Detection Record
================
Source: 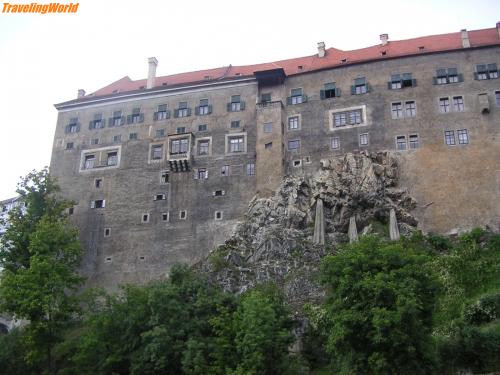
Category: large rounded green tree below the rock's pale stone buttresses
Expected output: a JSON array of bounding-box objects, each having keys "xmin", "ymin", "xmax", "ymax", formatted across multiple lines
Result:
[{"xmin": 322, "ymin": 236, "xmax": 437, "ymax": 374}]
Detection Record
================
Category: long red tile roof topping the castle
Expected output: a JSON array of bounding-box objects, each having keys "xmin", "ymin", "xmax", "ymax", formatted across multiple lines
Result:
[{"xmin": 88, "ymin": 28, "xmax": 500, "ymax": 99}]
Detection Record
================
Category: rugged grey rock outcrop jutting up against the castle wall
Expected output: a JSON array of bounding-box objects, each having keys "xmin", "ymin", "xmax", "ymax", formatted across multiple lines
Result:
[{"xmin": 197, "ymin": 152, "xmax": 417, "ymax": 306}]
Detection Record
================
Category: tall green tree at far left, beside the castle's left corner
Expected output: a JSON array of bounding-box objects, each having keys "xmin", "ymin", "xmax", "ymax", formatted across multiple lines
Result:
[{"xmin": 0, "ymin": 169, "xmax": 83, "ymax": 373}]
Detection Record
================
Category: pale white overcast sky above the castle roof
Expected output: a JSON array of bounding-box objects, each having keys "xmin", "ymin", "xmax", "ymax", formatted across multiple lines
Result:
[{"xmin": 0, "ymin": 0, "xmax": 500, "ymax": 200}]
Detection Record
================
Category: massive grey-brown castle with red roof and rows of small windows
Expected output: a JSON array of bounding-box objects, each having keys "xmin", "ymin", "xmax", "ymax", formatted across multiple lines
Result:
[{"xmin": 50, "ymin": 23, "xmax": 500, "ymax": 287}]
